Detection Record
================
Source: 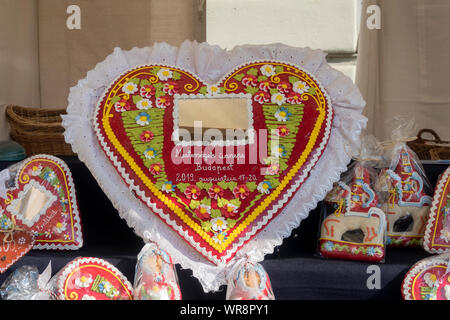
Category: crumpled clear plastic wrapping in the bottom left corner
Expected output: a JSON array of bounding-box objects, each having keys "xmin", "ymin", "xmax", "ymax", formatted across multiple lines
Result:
[{"xmin": 0, "ymin": 264, "xmax": 56, "ymax": 300}]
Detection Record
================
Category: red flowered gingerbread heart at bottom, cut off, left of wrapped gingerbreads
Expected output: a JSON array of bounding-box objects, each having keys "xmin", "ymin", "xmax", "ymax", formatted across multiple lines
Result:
[{"xmin": 57, "ymin": 257, "xmax": 133, "ymax": 300}]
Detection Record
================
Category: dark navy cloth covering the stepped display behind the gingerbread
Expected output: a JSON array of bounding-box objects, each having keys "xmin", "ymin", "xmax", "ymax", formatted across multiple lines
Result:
[{"xmin": 0, "ymin": 157, "xmax": 447, "ymax": 300}]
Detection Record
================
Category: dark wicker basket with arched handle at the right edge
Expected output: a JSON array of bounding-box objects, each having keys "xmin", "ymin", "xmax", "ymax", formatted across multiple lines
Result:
[{"xmin": 408, "ymin": 129, "xmax": 450, "ymax": 160}]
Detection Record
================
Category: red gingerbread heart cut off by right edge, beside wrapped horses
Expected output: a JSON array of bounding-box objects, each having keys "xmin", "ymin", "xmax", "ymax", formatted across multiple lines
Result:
[{"xmin": 423, "ymin": 167, "xmax": 450, "ymax": 253}]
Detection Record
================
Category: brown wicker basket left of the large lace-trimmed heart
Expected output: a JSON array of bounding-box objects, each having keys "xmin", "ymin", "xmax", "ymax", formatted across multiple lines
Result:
[{"xmin": 6, "ymin": 105, "xmax": 74, "ymax": 156}]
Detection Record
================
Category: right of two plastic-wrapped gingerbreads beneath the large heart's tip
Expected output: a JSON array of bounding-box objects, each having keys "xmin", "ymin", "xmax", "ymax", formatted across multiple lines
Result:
[{"xmin": 226, "ymin": 260, "xmax": 275, "ymax": 300}]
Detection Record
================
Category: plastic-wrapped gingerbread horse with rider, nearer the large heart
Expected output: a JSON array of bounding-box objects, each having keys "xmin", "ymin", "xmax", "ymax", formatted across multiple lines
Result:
[{"xmin": 318, "ymin": 136, "xmax": 386, "ymax": 262}]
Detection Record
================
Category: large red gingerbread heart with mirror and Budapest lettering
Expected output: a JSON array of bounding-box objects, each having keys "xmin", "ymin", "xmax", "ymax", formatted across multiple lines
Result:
[{"xmin": 94, "ymin": 61, "xmax": 333, "ymax": 264}]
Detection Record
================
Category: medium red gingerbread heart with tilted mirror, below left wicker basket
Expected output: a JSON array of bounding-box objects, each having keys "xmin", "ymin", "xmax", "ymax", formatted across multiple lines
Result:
[{"xmin": 0, "ymin": 155, "xmax": 83, "ymax": 249}]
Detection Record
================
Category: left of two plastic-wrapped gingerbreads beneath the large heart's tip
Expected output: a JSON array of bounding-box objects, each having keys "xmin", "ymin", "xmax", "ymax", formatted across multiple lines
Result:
[{"xmin": 134, "ymin": 242, "xmax": 181, "ymax": 300}]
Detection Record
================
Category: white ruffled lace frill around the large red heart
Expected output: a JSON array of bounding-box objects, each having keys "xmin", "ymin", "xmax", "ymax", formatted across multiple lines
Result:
[{"xmin": 63, "ymin": 41, "xmax": 367, "ymax": 292}]
